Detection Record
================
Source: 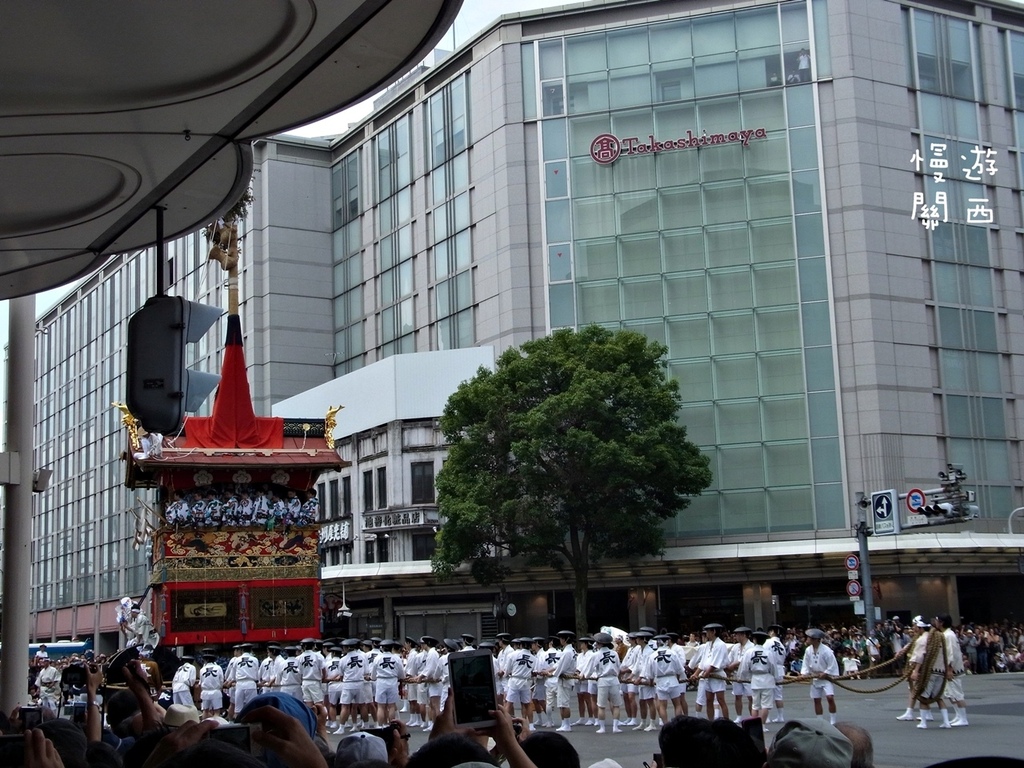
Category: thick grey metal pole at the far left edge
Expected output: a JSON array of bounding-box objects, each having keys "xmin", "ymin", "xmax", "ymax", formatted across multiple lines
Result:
[{"xmin": 0, "ymin": 296, "xmax": 36, "ymax": 712}]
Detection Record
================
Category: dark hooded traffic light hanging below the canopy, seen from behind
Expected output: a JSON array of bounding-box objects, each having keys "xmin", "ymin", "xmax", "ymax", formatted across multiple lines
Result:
[{"xmin": 125, "ymin": 296, "xmax": 224, "ymax": 434}]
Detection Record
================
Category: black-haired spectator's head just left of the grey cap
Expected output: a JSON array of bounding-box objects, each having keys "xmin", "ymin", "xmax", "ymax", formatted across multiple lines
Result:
[{"xmin": 657, "ymin": 715, "xmax": 764, "ymax": 768}]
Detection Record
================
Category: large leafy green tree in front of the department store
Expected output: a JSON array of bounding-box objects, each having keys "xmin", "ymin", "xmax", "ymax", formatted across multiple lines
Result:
[{"xmin": 433, "ymin": 326, "xmax": 712, "ymax": 633}]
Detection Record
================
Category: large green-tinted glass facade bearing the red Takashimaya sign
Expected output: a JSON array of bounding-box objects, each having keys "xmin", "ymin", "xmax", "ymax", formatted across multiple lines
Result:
[{"xmin": 522, "ymin": 2, "xmax": 844, "ymax": 536}]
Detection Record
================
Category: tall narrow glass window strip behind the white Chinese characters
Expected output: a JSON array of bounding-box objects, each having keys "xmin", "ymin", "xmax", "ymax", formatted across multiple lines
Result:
[{"xmin": 903, "ymin": 8, "xmax": 1024, "ymax": 518}]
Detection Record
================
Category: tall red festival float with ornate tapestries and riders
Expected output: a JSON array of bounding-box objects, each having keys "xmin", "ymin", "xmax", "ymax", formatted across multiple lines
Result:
[{"xmin": 115, "ymin": 221, "xmax": 348, "ymax": 647}]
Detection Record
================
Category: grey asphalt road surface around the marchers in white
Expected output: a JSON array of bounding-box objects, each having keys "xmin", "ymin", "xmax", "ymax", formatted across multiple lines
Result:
[{"xmin": 331, "ymin": 673, "xmax": 1024, "ymax": 768}]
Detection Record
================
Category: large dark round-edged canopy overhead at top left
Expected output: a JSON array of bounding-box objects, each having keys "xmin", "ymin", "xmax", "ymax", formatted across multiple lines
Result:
[{"xmin": 0, "ymin": 0, "xmax": 462, "ymax": 298}]
